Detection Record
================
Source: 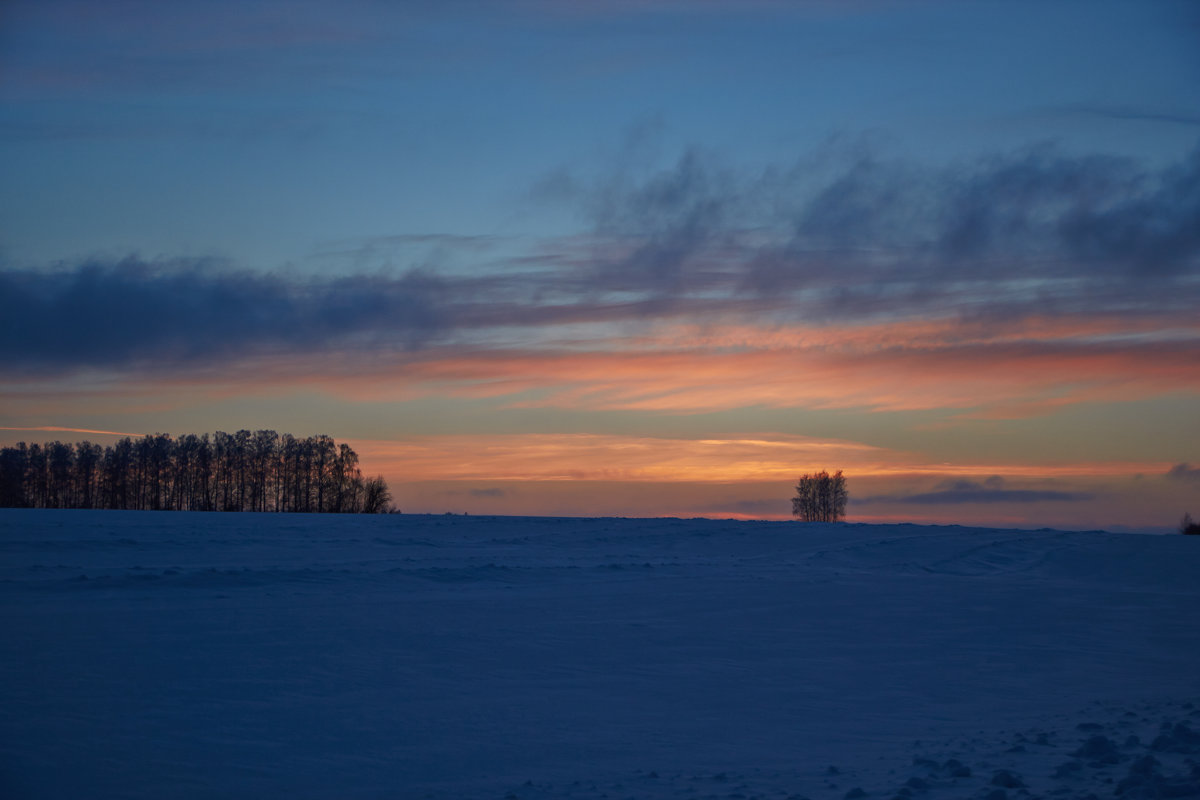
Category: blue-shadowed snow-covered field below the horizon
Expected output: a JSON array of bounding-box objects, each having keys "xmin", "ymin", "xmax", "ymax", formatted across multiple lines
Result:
[{"xmin": 0, "ymin": 510, "xmax": 1200, "ymax": 800}]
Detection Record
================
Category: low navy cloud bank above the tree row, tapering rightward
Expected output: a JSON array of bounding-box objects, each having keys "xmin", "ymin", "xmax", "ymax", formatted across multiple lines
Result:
[{"xmin": 0, "ymin": 254, "xmax": 777, "ymax": 373}]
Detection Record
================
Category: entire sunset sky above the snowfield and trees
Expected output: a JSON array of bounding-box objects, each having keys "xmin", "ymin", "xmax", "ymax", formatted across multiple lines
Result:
[{"xmin": 0, "ymin": 0, "xmax": 1200, "ymax": 530}]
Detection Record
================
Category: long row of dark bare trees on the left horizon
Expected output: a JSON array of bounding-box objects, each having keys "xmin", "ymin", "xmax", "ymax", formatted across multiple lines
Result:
[{"xmin": 0, "ymin": 431, "xmax": 391, "ymax": 513}]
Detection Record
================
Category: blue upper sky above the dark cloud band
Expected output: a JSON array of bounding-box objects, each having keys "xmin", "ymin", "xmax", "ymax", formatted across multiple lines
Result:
[{"xmin": 2, "ymin": 0, "xmax": 1200, "ymax": 269}]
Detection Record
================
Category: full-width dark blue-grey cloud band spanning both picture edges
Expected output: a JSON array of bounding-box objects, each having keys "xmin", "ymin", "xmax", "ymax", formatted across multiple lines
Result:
[{"xmin": 0, "ymin": 141, "xmax": 1200, "ymax": 372}]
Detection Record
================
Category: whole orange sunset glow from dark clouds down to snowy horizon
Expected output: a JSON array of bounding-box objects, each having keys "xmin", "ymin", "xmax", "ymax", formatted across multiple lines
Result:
[{"xmin": 2, "ymin": 319, "xmax": 1200, "ymax": 527}]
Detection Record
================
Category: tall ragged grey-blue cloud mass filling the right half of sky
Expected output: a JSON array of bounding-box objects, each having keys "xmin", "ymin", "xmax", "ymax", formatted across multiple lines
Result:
[{"xmin": 553, "ymin": 137, "xmax": 1200, "ymax": 319}]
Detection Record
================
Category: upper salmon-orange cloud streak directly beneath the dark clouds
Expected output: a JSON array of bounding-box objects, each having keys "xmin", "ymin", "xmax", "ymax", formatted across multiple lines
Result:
[{"xmin": 226, "ymin": 328, "xmax": 1200, "ymax": 417}]
